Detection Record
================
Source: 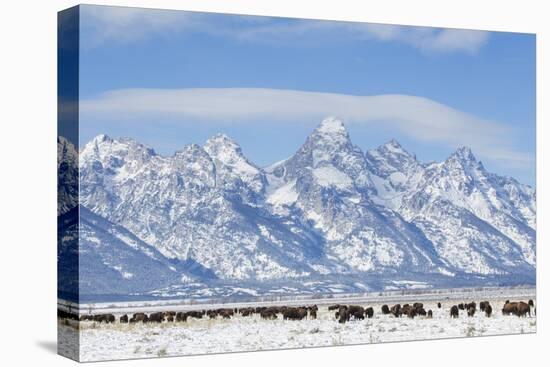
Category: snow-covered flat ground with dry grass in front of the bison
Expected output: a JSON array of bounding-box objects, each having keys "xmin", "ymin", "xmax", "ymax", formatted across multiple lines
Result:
[{"xmin": 59, "ymin": 295, "xmax": 536, "ymax": 361}]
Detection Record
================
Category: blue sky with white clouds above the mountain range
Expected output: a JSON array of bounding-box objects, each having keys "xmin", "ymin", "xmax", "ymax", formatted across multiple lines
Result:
[{"xmin": 80, "ymin": 6, "xmax": 535, "ymax": 185}]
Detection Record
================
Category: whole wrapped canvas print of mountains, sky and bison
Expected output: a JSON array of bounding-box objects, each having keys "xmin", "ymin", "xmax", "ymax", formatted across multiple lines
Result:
[{"xmin": 57, "ymin": 5, "xmax": 537, "ymax": 361}]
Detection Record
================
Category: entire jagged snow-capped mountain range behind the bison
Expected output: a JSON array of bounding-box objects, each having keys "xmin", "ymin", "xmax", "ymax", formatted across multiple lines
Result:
[{"xmin": 58, "ymin": 118, "xmax": 536, "ymax": 302}]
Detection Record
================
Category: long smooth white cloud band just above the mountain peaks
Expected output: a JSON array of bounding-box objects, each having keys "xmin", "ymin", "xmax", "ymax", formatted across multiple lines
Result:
[{"xmin": 80, "ymin": 88, "xmax": 533, "ymax": 166}]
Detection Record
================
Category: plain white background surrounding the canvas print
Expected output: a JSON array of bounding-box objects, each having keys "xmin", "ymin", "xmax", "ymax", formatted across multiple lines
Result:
[{"xmin": 0, "ymin": 0, "xmax": 550, "ymax": 367}]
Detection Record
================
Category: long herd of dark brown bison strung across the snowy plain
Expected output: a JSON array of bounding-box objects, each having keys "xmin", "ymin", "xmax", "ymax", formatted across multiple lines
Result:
[{"xmin": 57, "ymin": 300, "xmax": 536, "ymax": 324}]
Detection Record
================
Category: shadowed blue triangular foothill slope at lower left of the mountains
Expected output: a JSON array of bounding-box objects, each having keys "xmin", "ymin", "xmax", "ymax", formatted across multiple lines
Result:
[{"xmin": 58, "ymin": 207, "xmax": 194, "ymax": 295}]
